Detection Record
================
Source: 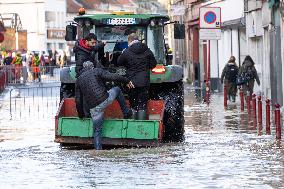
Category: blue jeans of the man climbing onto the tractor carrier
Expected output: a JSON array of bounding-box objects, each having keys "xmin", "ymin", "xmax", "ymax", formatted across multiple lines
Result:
[{"xmin": 90, "ymin": 87, "xmax": 129, "ymax": 150}]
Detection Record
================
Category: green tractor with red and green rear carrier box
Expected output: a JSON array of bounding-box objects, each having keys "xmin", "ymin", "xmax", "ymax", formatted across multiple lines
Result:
[{"xmin": 55, "ymin": 12, "xmax": 184, "ymax": 145}]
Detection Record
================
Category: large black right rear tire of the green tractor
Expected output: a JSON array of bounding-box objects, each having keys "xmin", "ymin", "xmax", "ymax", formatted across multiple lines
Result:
[{"xmin": 150, "ymin": 81, "xmax": 184, "ymax": 142}]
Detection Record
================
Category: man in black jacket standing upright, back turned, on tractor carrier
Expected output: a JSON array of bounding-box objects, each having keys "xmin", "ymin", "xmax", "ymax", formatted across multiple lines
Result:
[{"xmin": 117, "ymin": 33, "xmax": 157, "ymax": 119}]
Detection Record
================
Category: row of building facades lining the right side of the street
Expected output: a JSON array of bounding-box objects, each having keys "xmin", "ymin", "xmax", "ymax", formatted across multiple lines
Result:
[{"xmin": 169, "ymin": 0, "xmax": 284, "ymax": 105}]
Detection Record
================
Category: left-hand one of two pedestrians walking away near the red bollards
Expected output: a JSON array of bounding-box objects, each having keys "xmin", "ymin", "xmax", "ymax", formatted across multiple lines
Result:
[{"xmin": 221, "ymin": 56, "xmax": 239, "ymax": 102}]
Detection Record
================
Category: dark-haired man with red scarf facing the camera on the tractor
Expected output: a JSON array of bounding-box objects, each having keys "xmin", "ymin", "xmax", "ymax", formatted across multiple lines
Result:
[{"xmin": 73, "ymin": 33, "xmax": 105, "ymax": 77}]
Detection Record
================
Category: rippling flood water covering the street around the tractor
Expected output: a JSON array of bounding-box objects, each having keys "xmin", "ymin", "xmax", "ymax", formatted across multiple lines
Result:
[{"xmin": 0, "ymin": 87, "xmax": 284, "ymax": 189}]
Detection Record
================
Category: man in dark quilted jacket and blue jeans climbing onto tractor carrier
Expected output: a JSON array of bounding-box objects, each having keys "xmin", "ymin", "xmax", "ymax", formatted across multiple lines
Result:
[{"xmin": 75, "ymin": 61, "xmax": 134, "ymax": 150}]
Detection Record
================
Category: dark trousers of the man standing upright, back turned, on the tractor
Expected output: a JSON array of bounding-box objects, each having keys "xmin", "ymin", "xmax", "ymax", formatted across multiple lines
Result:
[{"xmin": 128, "ymin": 87, "xmax": 149, "ymax": 111}]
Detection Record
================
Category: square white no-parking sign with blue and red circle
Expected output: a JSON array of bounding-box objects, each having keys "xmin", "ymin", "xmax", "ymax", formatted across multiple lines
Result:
[{"xmin": 199, "ymin": 7, "xmax": 221, "ymax": 29}]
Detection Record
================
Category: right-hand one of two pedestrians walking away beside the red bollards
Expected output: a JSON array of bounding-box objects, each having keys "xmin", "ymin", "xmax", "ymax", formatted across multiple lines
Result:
[{"xmin": 238, "ymin": 55, "xmax": 260, "ymax": 95}]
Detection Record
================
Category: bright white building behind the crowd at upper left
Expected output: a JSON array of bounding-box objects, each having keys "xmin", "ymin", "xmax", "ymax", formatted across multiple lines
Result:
[{"xmin": 0, "ymin": 0, "xmax": 66, "ymax": 51}]
